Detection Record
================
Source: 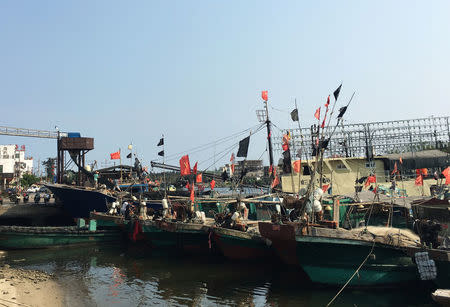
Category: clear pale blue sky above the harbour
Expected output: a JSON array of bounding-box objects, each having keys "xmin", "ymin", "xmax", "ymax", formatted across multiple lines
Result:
[{"xmin": 0, "ymin": 0, "xmax": 450, "ymax": 173}]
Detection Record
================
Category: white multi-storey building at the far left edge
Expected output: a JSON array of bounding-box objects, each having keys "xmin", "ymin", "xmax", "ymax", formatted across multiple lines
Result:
[{"xmin": 0, "ymin": 145, "xmax": 33, "ymax": 187}]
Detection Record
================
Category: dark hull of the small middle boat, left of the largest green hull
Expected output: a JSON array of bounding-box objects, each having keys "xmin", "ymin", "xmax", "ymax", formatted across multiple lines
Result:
[{"xmin": 213, "ymin": 227, "xmax": 275, "ymax": 260}]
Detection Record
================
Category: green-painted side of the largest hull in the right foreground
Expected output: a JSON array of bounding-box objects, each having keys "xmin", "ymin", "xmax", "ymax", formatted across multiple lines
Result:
[{"xmin": 296, "ymin": 236, "xmax": 419, "ymax": 286}]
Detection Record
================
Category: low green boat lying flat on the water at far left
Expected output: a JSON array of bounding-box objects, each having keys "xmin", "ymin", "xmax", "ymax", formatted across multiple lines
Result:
[{"xmin": 0, "ymin": 226, "xmax": 122, "ymax": 249}]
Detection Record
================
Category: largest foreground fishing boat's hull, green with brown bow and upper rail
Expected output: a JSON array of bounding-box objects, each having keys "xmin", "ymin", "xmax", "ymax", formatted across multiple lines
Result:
[{"xmin": 259, "ymin": 223, "xmax": 432, "ymax": 287}]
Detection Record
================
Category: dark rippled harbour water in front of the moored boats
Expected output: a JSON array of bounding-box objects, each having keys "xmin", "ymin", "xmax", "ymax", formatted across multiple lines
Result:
[{"xmin": 3, "ymin": 246, "xmax": 434, "ymax": 307}]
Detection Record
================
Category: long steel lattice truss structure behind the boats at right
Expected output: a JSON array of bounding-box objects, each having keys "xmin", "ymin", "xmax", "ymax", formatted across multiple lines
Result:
[{"xmin": 274, "ymin": 116, "xmax": 450, "ymax": 159}]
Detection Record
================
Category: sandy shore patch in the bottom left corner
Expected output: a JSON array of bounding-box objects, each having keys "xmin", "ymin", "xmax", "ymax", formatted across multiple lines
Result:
[{"xmin": 0, "ymin": 264, "xmax": 64, "ymax": 307}]
